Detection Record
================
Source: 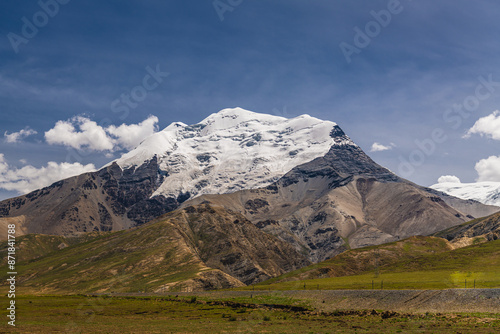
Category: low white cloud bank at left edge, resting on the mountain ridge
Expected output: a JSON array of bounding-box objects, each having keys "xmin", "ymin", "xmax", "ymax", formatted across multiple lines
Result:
[{"xmin": 0, "ymin": 153, "xmax": 96, "ymax": 194}]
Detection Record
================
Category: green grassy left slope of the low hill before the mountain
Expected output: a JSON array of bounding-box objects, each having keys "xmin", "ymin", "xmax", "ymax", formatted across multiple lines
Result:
[{"xmin": 7, "ymin": 219, "xmax": 208, "ymax": 292}]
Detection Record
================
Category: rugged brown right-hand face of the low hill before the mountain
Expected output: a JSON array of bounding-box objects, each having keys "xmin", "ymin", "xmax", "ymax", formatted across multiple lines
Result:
[{"xmin": 178, "ymin": 204, "xmax": 310, "ymax": 284}]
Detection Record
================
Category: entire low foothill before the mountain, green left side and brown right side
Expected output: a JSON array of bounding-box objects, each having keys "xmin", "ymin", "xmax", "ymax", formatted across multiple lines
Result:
[{"xmin": 8, "ymin": 201, "xmax": 310, "ymax": 293}]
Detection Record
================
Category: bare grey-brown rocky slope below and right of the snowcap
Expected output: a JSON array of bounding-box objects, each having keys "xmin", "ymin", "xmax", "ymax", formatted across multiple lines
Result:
[{"xmin": 190, "ymin": 138, "xmax": 480, "ymax": 262}]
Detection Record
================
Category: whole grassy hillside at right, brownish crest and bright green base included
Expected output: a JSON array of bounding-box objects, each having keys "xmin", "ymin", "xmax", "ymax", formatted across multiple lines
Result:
[{"xmin": 246, "ymin": 237, "xmax": 500, "ymax": 290}]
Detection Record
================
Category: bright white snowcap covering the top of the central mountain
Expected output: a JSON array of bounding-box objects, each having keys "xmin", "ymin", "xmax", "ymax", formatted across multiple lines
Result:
[{"xmin": 116, "ymin": 108, "xmax": 355, "ymax": 201}]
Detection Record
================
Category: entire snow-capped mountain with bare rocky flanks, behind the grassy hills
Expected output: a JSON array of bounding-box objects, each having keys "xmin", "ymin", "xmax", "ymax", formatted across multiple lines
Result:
[{"xmin": 0, "ymin": 108, "xmax": 499, "ymax": 261}]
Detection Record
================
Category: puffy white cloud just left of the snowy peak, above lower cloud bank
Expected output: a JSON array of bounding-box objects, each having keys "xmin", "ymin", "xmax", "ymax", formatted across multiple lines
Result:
[{"xmin": 45, "ymin": 116, "xmax": 158, "ymax": 152}]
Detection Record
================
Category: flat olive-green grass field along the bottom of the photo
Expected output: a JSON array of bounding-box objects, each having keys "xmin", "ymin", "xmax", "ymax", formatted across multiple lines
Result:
[{"xmin": 0, "ymin": 296, "xmax": 500, "ymax": 333}]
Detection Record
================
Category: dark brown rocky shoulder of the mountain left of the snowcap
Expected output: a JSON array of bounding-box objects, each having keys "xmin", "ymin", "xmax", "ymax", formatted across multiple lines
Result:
[{"xmin": 0, "ymin": 159, "xmax": 173, "ymax": 238}]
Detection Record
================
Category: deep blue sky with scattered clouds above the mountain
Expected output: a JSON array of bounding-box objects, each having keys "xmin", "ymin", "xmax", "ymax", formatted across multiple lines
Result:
[{"xmin": 0, "ymin": 0, "xmax": 500, "ymax": 199}]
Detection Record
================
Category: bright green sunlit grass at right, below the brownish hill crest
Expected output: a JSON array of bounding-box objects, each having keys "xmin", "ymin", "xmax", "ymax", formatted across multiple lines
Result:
[{"xmin": 240, "ymin": 240, "xmax": 500, "ymax": 290}]
